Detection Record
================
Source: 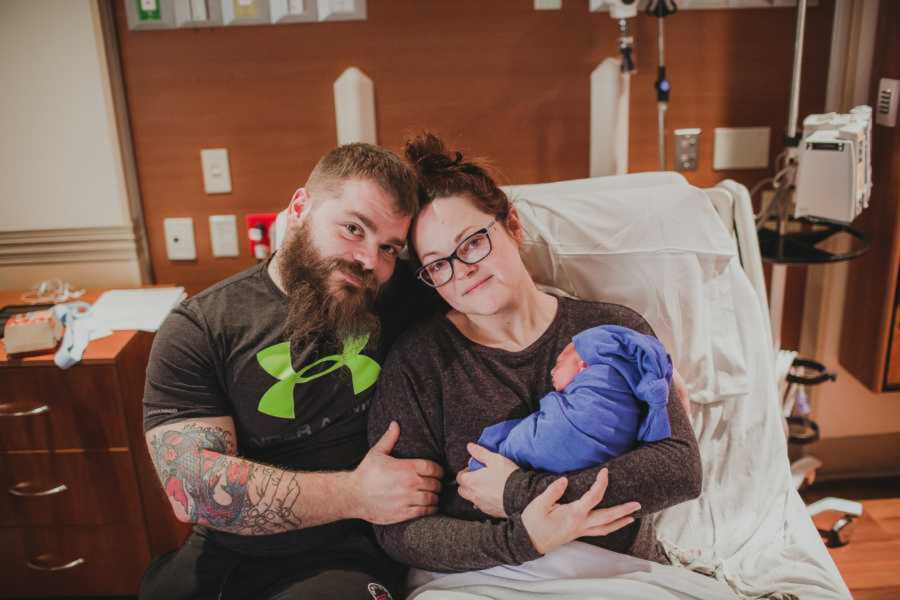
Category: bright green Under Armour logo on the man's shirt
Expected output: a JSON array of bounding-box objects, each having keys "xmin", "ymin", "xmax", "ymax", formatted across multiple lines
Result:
[{"xmin": 256, "ymin": 335, "xmax": 381, "ymax": 419}]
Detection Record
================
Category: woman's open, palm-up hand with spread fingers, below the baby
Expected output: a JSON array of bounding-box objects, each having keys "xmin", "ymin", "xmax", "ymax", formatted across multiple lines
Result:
[{"xmin": 522, "ymin": 469, "xmax": 641, "ymax": 554}]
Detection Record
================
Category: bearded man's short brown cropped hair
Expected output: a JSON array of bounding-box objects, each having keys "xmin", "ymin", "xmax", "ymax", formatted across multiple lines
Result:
[{"xmin": 306, "ymin": 142, "xmax": 419, "ymax": 216}]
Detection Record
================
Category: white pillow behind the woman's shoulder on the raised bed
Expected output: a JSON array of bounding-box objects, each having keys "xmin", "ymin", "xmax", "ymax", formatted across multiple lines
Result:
[{"xmin": 504, "ymin": 173, "xmax": 749, "ymax": 403}]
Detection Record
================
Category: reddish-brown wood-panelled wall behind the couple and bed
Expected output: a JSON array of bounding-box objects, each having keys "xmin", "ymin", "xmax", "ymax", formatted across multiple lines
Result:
[{"xmin": 116, "ymin": 0, "xmax": 833, "ymax": 346}]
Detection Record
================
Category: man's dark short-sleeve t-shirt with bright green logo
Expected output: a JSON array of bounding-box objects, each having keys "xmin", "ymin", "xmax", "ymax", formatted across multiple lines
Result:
[{"xmin": 144, "ymin": 255, "xmax": 389, "ymax": 555}]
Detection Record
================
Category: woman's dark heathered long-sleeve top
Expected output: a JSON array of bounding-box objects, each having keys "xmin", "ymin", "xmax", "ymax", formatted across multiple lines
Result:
[{"xmin": 369, "ymin": 298, "xmax": 702, "ymax": 572}]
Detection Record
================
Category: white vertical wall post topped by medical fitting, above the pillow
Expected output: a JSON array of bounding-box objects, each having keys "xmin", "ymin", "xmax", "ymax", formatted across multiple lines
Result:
[{"xmin": 588, "ymin": 0, "xmax": 638, "ymax": 177}]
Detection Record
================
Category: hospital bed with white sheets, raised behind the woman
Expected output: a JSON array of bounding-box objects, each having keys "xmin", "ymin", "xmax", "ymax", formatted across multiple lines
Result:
[{"xmin": 274, "ymin": 172, "xmax": 850, "ymax": 600}]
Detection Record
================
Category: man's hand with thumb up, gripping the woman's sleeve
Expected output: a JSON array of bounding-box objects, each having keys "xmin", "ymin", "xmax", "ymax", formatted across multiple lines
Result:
[{"xmin": 350, "ymin": 421, "xmax": 444, "ymax": 525}]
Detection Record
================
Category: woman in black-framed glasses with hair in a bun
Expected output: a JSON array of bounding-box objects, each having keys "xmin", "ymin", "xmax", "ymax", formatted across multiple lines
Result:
[{"xmin": 369, "ymin": 134, "xmax": 701, "ymax": 572}]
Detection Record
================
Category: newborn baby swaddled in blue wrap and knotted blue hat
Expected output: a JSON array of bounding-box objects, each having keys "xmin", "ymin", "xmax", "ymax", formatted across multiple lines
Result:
[{"xmin": 469, "ymin": 325, "xmax": 672, "ymax": 473}]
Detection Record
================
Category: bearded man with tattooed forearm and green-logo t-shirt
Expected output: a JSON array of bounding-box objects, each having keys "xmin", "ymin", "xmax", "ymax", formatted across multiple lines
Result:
[{"xmin": 140, "ymin": 144, "xmax": 442, "ymax": 600}]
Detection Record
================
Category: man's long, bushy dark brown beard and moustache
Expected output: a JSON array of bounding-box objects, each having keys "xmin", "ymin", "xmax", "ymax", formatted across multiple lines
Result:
[{"xmin": 276, "ymin": 222, "xmax": 380, "ymax": 353}]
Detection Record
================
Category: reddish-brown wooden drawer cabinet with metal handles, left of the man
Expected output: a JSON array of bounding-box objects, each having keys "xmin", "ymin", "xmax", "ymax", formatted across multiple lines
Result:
[{"xmin": 0, "ymin": 293, "xmax": 188, "ymax": 598}]
